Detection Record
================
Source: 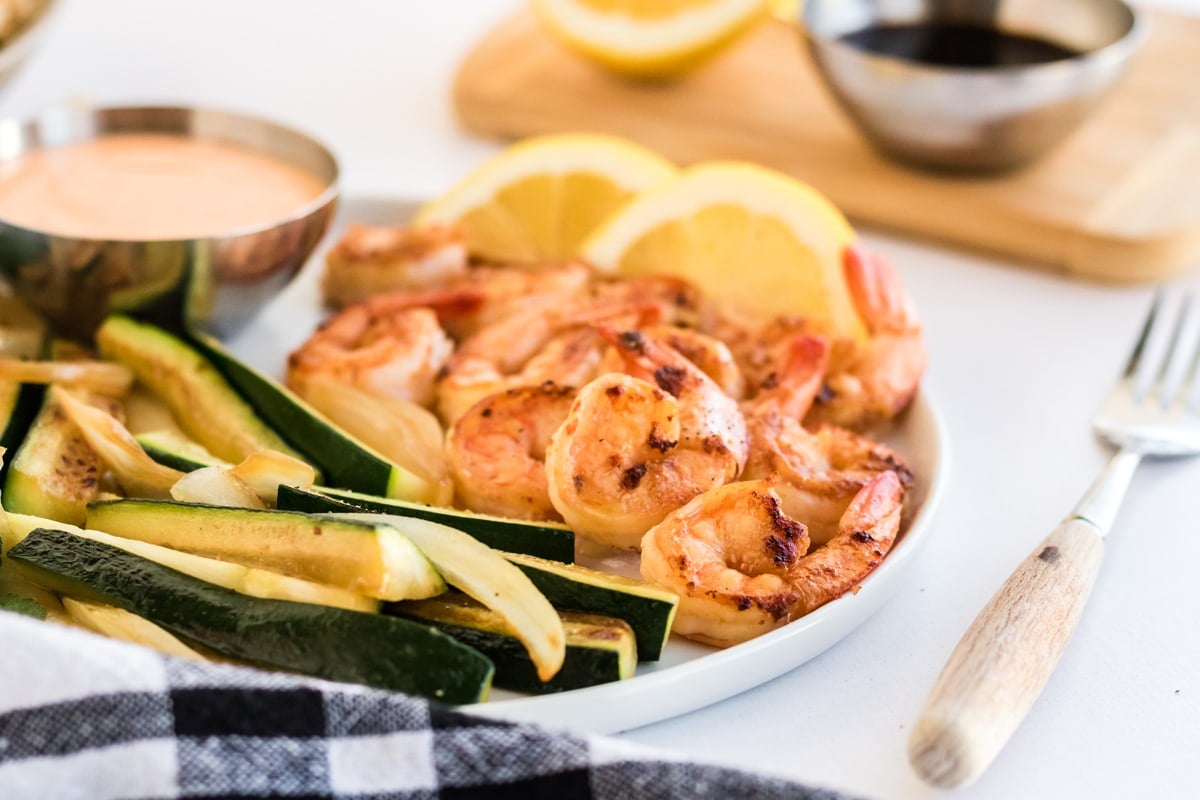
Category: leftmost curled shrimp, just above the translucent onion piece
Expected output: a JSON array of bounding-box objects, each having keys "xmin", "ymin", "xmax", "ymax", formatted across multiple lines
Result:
[{"xmin": 287, "ymin": 303, "xmax": 454, "ymax": 405}]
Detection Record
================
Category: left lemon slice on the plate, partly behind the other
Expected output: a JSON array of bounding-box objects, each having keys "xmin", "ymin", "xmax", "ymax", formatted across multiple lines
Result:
[{"xmin": 415, "ymin": 133, "xmax": 676, "ymax": 263}]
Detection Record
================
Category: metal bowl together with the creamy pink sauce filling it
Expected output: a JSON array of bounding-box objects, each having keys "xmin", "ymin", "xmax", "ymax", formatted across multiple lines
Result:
[{"xmin": 0, "ymin": 107, "xmax": 338, "ymax": 339}]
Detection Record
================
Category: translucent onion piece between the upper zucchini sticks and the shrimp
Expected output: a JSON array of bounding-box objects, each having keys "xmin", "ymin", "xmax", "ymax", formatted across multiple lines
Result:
[{"xmin": 300, "ymin": 377, "xmax": 454, "ymax": 505}]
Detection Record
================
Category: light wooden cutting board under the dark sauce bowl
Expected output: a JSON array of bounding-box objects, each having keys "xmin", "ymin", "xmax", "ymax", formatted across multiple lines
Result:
[{"xmin": 454, "ymin": 12, "xmax": 1200, "ymax": 282}]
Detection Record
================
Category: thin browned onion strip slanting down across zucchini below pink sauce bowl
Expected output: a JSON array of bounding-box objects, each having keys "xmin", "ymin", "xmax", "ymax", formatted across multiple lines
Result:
[{"xmin": 50, "ymin": 386, "xmax": 184, "ymax": 499}]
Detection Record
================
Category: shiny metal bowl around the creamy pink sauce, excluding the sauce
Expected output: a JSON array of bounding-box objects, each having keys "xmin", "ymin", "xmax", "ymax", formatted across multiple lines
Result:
[{"xmin": 0, "ymin": 107, "xmax": 338, "ymax": 338}]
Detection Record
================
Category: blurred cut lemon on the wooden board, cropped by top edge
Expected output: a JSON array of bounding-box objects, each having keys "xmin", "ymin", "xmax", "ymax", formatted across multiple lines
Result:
[{"xmin": 533, "ymin": 0, "xmax": 769, "ymax": 77}]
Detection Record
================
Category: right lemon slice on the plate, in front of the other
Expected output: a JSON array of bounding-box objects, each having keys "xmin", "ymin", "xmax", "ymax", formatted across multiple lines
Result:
[{"xmin": 583, "ymin": 163, "xmax": 865, "ymax": 338}]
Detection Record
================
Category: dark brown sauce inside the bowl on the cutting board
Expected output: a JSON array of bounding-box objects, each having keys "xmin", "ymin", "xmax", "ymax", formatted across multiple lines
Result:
[{"xmin": 841, "ymin": 23, "xmax": 1080, "ymax": 67}]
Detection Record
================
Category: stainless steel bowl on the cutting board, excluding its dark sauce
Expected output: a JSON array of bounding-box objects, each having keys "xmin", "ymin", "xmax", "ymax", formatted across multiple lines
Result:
[{"xmin": 800, "ymin": 0, "xmax": 1145, "ymax": 170}]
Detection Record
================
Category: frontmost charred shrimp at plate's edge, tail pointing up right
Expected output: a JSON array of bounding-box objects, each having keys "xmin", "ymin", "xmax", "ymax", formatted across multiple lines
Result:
[{"xmin": 641, "ymin": 473, "xmax": 904, "ymax": 646}]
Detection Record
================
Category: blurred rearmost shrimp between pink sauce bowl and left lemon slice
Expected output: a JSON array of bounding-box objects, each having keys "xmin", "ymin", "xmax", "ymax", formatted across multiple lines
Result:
[{"xmin": 322, "ymin": 223, "xmax": 467, "ymax": 308}]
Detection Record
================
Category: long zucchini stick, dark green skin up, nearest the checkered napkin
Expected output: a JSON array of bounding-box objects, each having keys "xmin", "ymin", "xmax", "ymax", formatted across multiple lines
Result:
[{"xmin": 8, "ymin": 528, "xmax": 493, "ymax": 704}]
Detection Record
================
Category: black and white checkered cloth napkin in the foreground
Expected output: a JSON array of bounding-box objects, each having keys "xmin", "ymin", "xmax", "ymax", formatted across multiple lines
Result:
[{"xmin": 0, "ymin": 612, "xmax": 840, "ymax": 800}]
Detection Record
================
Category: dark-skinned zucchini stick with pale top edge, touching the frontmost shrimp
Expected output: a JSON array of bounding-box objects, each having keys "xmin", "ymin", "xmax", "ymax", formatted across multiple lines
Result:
[{"xmin": 506, "ymin": 553, "xmax": 679, "ymax": 661}]
